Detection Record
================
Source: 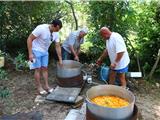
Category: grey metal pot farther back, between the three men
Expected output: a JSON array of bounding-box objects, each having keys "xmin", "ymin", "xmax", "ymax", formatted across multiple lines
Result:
[{"xmin": 57, "ymin": 60, "xmax": 82, "ymax": 78}]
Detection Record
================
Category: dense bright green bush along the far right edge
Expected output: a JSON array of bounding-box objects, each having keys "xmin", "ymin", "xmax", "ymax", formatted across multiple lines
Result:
[{"xmin": 137, "ymin": 1, "xmax": 160, "ymax": 71}]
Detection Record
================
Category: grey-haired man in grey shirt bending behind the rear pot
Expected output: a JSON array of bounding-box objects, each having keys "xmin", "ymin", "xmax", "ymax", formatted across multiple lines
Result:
[{"xmin": 62, "ymin": 28, "xmax": 88, "ymax": 61}]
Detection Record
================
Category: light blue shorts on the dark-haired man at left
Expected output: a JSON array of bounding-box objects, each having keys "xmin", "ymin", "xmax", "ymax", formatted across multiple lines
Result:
[{"xmin": 32, "ymin": 50, "xmax": 48, "ymax": 69}]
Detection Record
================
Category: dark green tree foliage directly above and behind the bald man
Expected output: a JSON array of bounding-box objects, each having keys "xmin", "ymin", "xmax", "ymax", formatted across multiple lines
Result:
[{"xmin": 86, "ymin": 1, "xmax": 135, "ymax": 62}]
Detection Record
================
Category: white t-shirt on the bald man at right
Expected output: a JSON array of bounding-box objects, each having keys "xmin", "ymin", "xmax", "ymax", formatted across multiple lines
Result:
[{"xmin": 106, "ymin": 32, "xmax": 130, "ymax": 70}]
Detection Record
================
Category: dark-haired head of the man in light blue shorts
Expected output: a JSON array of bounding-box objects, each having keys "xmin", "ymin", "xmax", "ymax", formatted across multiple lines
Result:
[{"xmin": 50, "ymin": 19, "xmax": 62, "ymax": 32}]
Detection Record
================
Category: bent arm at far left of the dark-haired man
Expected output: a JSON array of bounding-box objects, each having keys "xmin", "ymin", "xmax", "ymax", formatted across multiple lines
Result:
[{"xmin": 27, "ymin": 34, "xmax": 36, "ymax": 61}]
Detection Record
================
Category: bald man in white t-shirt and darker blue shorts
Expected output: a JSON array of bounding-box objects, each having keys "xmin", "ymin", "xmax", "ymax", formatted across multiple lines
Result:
[{"xmin": 97, "ymin": 27, "xmax": 130, "ymax": 87}]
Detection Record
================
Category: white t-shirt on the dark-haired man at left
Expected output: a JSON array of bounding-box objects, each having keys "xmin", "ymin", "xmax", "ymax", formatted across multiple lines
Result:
[{"xmin": 32, "ymin": 24, "xmax": 59, "ymax": 52}]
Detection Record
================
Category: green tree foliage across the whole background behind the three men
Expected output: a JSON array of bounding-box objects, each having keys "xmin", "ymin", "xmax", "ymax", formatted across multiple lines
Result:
[{"xmin": 0, "ymin": 0, "xmax": 160, "ymax": 72}]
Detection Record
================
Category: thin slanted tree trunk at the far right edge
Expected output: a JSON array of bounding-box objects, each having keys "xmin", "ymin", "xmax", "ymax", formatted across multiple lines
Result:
[{"xmin": 147, "ymin": 49, "xmax": 160, "ymax": 80}]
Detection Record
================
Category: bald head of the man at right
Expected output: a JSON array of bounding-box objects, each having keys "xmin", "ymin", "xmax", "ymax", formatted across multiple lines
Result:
[{"xmin": 100, "ymin": 27, "xmax": 112, "ymax": 40}]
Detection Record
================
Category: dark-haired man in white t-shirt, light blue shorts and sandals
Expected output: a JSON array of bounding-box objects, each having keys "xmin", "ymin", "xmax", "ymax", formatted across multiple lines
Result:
[{"xmin": 27, "ymin": 20, "xmax": 62, "ymax": 94}]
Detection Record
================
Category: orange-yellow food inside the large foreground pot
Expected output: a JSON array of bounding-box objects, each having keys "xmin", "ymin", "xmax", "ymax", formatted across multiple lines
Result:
[{"xmin": 91, "ymin": 96, "xmax": 129, "ymax": 108}]
